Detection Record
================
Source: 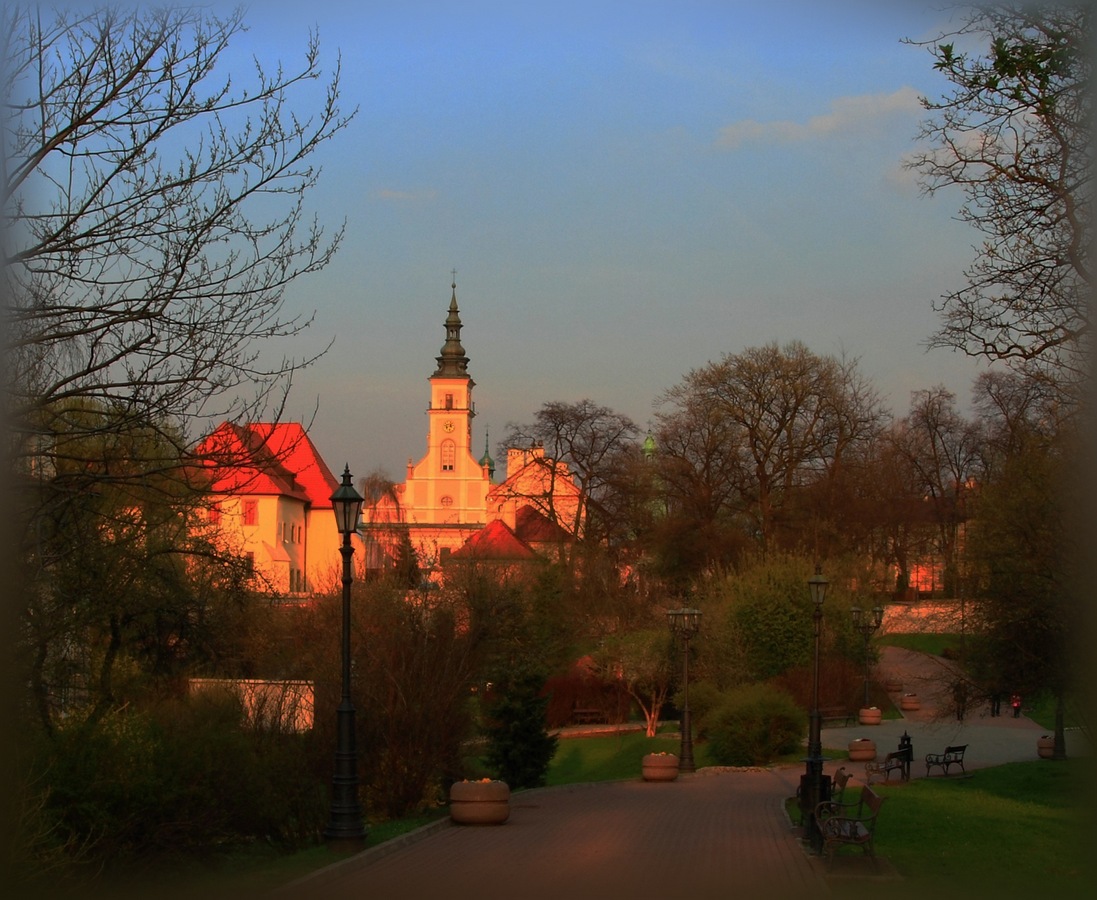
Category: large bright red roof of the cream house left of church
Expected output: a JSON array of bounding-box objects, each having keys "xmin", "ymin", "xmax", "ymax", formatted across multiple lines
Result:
[{"xmin": 197, "ymin": 423, "xmax": 339, "ymax": 509}]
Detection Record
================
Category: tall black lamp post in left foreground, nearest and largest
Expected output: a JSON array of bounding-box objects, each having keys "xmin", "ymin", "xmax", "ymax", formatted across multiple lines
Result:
[{"xmin": 324, "ymin": 465, "xmax": 365, "ymax": 847}]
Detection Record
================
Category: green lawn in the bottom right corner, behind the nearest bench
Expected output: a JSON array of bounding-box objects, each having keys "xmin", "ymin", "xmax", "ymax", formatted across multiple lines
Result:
[{"xmin": 792, "ymin": 758, "xmax": 1095, "ymax": 898}]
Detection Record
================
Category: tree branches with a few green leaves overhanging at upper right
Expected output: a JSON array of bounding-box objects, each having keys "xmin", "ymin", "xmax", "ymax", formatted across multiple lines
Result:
[{"xmin": 909, "ymin": 2, "xmax": 1093, "ymax": 400}]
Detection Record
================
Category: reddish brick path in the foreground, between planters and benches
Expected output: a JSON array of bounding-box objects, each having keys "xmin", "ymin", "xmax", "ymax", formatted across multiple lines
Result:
[{"xmin": 291, "ymin": 770, "xmax": 827, "ymax": 900}]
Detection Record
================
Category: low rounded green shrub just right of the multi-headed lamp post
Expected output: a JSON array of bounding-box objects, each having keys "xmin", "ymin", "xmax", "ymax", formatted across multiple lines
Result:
[{"xmin": 708, "ymin": 684, "xmax": 804, "ymax": 766}]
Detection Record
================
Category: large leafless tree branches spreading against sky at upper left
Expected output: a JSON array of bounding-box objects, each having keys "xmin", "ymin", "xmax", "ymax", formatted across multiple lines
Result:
[{"xmin": 0, "ymin": 4, "xmax": 353, "ymax": 485}]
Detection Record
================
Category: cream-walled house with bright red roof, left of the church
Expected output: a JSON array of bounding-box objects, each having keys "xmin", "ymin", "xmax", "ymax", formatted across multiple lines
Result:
[{"xmin": 199, "ymin": 423, "xmax": 351, "ymax": 595}]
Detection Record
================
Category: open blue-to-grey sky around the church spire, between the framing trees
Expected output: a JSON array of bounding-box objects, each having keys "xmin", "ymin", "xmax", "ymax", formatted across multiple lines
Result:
[{"xmin": 227, "ymin": 0, "xmax": 984, "ymax": 481}]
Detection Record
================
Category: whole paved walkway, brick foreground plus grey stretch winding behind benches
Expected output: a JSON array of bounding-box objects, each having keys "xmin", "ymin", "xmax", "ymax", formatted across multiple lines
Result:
[{"xmin": 283, "ymin": 648, "xmax": 1081, "ymax": 900}]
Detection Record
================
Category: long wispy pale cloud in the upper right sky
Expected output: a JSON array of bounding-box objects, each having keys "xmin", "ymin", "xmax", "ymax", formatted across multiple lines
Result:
[{"xmin": 716, "ymin": 88, "xmax": 921, "ymax": 149}]
